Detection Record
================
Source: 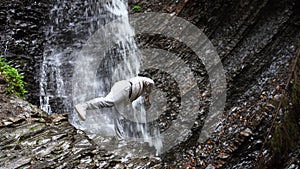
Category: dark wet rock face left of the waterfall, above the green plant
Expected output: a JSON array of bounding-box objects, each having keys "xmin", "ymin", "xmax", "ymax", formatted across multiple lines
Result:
[{"xmin": 0, "ymin": 0, "xmax": 51, "ymax": 104}]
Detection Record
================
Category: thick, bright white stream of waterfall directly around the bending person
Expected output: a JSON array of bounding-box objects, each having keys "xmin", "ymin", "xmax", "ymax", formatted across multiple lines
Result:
[{"xmin": 71, "ymin": 0, "xmax": 162, "ymax": 154}]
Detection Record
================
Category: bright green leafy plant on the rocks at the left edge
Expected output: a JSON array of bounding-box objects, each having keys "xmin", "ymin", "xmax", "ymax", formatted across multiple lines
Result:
[{"xmin": 0, "ymin": 57, "xmax": 27, "ymax": 98}]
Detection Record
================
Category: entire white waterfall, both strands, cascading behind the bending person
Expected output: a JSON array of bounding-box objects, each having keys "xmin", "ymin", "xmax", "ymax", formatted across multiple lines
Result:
[{"xmin": 40, "ymin": 0, "xmax": 161, "ymax": 156}]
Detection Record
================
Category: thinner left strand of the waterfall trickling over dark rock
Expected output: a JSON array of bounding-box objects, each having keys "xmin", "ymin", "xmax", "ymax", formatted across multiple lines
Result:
[{"xmin": 40, "ymin": 0, "xmax": 104, "ymax": 114}]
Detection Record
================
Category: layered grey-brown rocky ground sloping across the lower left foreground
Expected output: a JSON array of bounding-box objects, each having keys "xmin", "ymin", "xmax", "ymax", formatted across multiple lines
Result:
[{"xmin": 0, "ymin": 76, "xmax": 162, "ymax": 169}]
